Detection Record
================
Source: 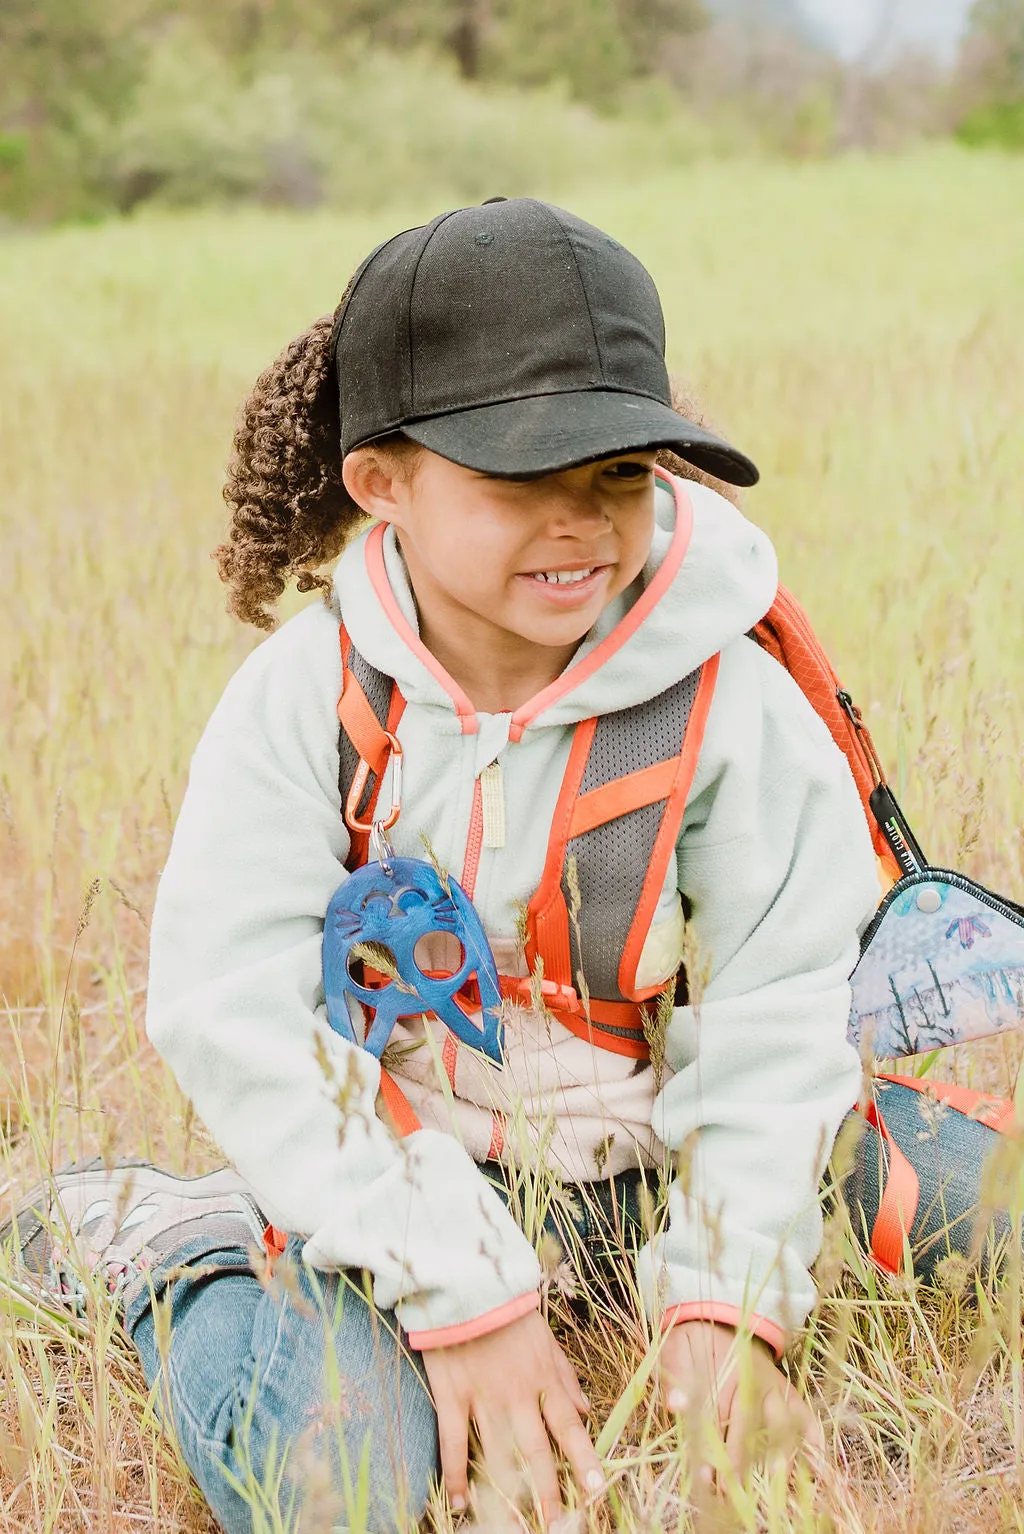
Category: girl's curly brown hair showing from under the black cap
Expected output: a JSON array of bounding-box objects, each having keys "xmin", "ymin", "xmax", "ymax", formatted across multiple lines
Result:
[{"xmin": 215, "ymin": 298, "xmax": 736, "ymax": 629}]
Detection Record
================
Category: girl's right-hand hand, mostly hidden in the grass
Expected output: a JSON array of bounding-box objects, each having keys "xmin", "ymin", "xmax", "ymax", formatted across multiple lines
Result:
[{"xmin": 659, "ymin": 1321, "xmax": 825, "ymax": 1480}]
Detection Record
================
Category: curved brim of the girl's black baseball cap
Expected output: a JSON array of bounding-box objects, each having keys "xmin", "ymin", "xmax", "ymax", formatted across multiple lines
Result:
[{"xmin": 400, "ymin": 390, "xmax": 759, "ymax": 485}]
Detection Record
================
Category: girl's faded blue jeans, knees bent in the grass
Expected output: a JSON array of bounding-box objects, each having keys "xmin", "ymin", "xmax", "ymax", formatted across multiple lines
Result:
[{"xmin": 124, "ymin": 1086, "xmax": 1006, "ymax": 1534}]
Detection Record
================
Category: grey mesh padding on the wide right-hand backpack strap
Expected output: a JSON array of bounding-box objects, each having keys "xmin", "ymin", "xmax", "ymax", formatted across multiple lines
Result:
[{"xmin": 563, "ymin": 667, "xmax": 701, "ymax": 1002}]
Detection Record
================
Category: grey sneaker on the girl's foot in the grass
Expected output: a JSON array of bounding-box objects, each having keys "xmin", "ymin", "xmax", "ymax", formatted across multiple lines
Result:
[{"xmin": 0, "ymin": 1157, "xmax": 267, "ymax": 1315}]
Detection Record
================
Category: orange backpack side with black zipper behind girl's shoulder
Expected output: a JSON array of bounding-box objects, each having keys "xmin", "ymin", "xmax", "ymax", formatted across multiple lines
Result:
[{"xmin": 751, "ymin": 586, "xmax": 927, "ymax": 882}]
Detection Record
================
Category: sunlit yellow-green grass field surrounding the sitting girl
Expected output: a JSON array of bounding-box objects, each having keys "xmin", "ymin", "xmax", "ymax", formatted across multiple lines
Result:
[{"xmin": 0, "ymin": 149, "xmax": 1024, "ymax": 1534}]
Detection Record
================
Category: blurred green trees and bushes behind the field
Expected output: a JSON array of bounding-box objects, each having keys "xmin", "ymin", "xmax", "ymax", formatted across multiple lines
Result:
[{"xmin": 0, "ymin": 0, "xmax": 1024, "ymax": 221}]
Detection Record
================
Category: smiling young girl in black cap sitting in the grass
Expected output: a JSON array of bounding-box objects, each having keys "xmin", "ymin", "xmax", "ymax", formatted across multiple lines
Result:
[{"xmin": 4, "ymin": 199, "xmax": 950, "ymax": 1531}]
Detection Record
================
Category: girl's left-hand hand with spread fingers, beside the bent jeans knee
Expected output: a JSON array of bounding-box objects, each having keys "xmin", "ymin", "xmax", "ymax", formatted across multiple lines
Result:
[{"xmin": 422, "ymin": 1310, "xmax": 604, "ymax": 1523}]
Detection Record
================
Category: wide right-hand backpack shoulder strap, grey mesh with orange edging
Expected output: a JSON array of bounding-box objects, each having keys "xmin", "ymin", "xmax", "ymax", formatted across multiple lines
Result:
[{"xmin": 524, "ymin": 657, "xmax": 717, "ymax": 1058}]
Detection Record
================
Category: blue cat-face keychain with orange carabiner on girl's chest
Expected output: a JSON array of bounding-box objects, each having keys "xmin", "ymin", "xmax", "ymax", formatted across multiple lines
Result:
[{"xmin": 323, "ymin": 733, "xmax": 503, "ymax": 1065}]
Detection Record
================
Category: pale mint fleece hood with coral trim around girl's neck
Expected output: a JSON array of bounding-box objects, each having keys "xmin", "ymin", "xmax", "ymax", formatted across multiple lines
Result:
[{"xmin": 334, "ymin": 471, "xmax": 779, "ymax": 739}]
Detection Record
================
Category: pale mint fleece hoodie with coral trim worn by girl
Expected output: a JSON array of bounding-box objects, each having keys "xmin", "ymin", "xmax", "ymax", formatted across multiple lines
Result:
[{"xmin": 147, "ymin": 480, "xmax": 878, "ymax": 1347}]
